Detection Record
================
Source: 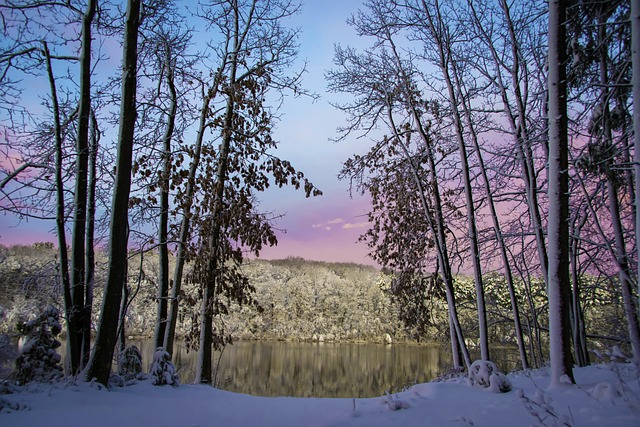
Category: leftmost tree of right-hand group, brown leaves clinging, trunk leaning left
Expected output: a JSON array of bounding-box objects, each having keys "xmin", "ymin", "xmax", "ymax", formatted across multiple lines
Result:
[{"xmin": 327, "ymin": 17, "xmax": 471, "ymax": 367}]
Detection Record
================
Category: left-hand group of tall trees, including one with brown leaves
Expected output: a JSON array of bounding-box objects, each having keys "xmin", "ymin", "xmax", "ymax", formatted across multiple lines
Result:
[{"xmin": 0, "ymin": 0, "xmax": 321, "ymax": 384}]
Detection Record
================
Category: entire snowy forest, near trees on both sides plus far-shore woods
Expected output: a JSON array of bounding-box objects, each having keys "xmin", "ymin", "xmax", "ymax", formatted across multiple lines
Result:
[{"xmin": 0, "ymin": 0, "xmax": 640, "ymax": 394}]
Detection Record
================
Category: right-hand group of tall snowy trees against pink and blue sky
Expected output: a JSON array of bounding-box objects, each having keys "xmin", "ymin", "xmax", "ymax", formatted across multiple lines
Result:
[{"xmin": 327, "ymin": 0, "xmax": 639, "ymax": 384}]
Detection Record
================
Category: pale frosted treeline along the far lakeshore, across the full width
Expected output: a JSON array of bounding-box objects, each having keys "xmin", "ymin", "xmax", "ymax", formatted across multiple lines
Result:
[{"xmin": 0, "ymin": 244, "xmax": 626, "ymax": 363}]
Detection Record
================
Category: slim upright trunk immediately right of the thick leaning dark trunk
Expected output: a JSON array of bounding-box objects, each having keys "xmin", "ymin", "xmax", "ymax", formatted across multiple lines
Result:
[{"xmin": 154, "ymin": 47, "xmax": 178, "ymax": 350}]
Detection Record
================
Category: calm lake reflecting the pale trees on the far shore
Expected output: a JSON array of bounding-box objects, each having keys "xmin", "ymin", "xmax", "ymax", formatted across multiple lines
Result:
[{"xmin": 112, "ymin": 340, "xmax": 513, "ymax": 398}]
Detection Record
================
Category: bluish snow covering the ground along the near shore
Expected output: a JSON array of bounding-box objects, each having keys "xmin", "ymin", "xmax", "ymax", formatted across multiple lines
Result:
[{"xmin": 0, "ymin": 363, "xmax": 640, "ymax": 427}]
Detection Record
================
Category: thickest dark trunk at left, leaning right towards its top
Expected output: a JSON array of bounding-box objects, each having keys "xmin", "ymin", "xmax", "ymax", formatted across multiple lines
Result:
[{"xmin": 85, "ymin": 0, "xmax": 141, "ymax": 385}]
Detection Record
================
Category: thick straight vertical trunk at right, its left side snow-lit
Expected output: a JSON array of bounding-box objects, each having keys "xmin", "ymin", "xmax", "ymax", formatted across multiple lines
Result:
[{"xmin": 547, "ymin": 0, "xmax": 575, "ymax": 387}]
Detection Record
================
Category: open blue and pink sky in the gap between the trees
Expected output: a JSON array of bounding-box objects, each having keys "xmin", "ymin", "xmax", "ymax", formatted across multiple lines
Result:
[{"xmin": 0, "ymin": 0, "xmax": 374, "ymax": 264}]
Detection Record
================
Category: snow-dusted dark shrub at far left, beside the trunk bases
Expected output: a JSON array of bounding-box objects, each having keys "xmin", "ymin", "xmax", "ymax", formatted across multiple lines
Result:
[{"xmin": 16, "ymin": 306, "xmax": 62, "ymax": 383}]
